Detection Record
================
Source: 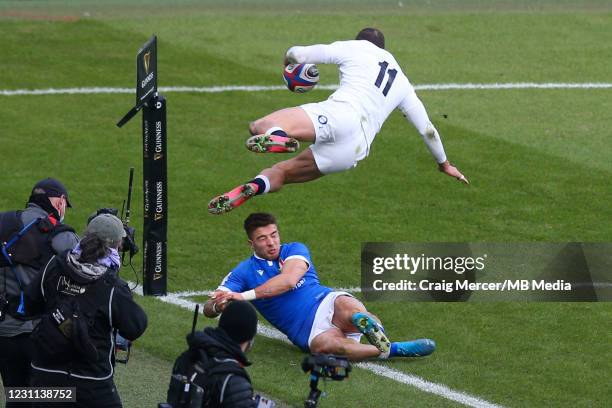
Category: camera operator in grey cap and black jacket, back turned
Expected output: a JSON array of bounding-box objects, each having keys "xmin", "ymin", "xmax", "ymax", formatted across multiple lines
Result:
[{"xmin": 26, "ymin": 214, "xmax": 147, "ymax": 408}]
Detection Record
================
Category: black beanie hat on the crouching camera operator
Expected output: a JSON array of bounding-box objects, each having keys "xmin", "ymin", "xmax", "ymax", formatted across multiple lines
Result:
[{"xmin": 219, "ymin": 300, "xmax": 257, "ymax": 344}]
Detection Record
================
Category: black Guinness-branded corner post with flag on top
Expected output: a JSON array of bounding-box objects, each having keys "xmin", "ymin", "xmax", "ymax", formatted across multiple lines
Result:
[{"xmin": 117, "ymin": 36, "xmax": 168, "ymax": 295}]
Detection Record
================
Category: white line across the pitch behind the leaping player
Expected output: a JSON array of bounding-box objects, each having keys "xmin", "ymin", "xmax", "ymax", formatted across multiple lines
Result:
[{"xmin": 0, "ymin": 82, "xmax": 612, "ymax": 96}]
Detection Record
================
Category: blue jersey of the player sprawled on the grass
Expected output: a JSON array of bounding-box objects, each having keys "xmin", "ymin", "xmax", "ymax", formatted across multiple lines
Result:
[{"xmin": 218, "ymin": 242, "xmax": 331, "ymax": 352}]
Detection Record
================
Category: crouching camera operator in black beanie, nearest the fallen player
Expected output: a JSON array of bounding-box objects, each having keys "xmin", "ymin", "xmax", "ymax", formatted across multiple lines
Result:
[{"xmin": 167, "ymin": 301, "xmax": 260, "ymax": 408}]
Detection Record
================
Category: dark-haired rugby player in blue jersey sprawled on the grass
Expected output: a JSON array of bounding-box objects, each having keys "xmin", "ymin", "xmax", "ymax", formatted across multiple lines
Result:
[{"xmin": 204, "ymin": 213, "xmax": 436, "ymax": 361}]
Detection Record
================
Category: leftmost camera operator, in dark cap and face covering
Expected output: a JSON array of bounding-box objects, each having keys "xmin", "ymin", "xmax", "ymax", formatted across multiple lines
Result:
[{"xmin": 0, "ymin": 178, "xmax": 79, "ymax": 407}]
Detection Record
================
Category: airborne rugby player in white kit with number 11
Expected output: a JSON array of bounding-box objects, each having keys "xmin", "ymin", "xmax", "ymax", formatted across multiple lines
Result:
[{"xmin": 208, "ymin": 28, "xmax": 469, "ymax": 214}]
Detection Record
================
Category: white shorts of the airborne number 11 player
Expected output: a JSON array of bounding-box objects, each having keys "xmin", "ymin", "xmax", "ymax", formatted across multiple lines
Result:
[{"xmin": 300, "ymin": 99, "xmax": 372, "ymax": 174}]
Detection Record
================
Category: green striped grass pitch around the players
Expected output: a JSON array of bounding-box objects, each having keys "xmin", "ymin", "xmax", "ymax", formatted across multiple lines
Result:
[{"xmin": 0, "ymin": 0, "xmax": 612, "ymax": 407}]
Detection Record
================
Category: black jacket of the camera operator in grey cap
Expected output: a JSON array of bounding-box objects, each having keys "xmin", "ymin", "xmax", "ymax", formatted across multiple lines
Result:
[{"xmin": 26, "ymin": 251, "xmax": 147, "ymax": 380}]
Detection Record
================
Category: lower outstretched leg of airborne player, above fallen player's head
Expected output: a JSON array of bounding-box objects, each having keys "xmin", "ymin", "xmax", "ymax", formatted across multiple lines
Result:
[{"xmin": 208, "ymin": 149, "xmax": 323, "ymax": 215}]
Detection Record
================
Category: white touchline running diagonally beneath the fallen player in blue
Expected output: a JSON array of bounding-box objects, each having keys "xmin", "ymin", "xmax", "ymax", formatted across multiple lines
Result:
[{"xmin": 128, "ymin": 282, "xmax": 502, "ymax": 408}]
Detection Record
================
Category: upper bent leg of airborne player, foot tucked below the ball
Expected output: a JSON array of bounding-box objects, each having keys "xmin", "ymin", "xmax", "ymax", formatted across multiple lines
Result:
[{"xmin": 246, "ymin": 107, "xmax": 315, "ymax": 153}]
